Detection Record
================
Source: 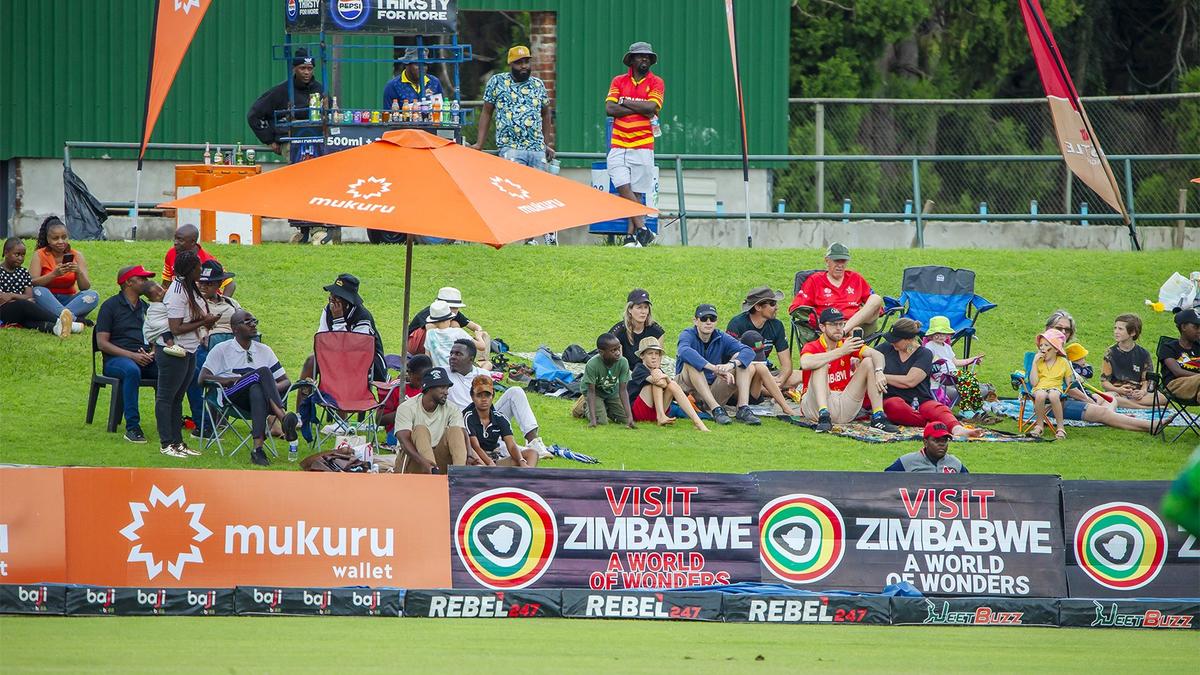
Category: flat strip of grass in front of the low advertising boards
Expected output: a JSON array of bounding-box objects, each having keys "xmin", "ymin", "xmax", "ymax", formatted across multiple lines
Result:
[{"xmin": 0, "ymin": 617, "xmax": 1198, "ymax": 674}]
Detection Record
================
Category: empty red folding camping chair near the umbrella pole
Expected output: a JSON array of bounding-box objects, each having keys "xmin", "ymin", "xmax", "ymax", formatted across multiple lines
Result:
[{"xmin": 311, "ymin": 330, "xmax": 383, "ymax": 452}]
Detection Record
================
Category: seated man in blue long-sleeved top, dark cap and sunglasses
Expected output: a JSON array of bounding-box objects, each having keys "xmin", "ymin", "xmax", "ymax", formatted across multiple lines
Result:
[{"xmin": 676, "ymin": 304, "xmax": 797, "ymax": 424}]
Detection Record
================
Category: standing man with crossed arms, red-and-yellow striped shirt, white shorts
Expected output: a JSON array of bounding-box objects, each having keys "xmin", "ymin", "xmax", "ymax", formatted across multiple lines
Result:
[{"xmin": 605, "ymin": 42, "xmax": 664, "ymax": 246}]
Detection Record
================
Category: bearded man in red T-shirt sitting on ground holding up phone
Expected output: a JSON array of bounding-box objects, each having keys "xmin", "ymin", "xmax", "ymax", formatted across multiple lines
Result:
[{"xmin": 800, "ymin": 307, "xmax": 899, "ymax": 434}]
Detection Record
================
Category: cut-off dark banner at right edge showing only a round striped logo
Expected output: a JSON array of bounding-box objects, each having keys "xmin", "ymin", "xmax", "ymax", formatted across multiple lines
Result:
[{"xmin": 1062, "ymin": 480, "xmax": 1200, "ymax": 598}]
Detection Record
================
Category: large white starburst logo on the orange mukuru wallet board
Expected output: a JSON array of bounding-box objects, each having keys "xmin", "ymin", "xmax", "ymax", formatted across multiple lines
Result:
[{"xmin": 120, "ymin": 485, "xmax": 212, "ymax": 579}]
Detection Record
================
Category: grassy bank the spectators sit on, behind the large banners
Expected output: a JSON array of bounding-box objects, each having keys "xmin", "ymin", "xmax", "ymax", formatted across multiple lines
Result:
[{"xmin": 0, "ymin": 241, "xmax": 1195, "ymax": 479}]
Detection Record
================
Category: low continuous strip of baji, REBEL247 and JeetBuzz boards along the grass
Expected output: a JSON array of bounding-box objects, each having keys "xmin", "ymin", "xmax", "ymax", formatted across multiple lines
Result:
[{"xmin": 7, "ymin": 584, "xmax": 1200, "ymax": 631}]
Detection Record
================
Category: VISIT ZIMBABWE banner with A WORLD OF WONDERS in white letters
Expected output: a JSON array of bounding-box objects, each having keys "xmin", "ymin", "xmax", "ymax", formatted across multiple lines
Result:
[{"xmin": 751, "ymin": 471, "xmax": 1066, "ymax": 597}]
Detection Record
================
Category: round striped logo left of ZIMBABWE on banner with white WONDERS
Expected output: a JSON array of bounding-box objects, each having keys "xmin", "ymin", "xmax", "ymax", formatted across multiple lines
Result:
[{"xmin": 758, "ymin": 495, "xmax": 846, "ymax": 584}]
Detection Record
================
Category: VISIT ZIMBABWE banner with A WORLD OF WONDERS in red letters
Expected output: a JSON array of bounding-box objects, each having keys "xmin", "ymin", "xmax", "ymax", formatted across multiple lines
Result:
[{"xmin": 450, "ymin": 467, "xmax": 758, "ymax": 591}]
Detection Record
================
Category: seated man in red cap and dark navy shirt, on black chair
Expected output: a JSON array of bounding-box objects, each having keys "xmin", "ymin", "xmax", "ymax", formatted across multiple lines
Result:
[{"xmin": 96, "ymin": 265, "xmax": 159, "ymax": 443}]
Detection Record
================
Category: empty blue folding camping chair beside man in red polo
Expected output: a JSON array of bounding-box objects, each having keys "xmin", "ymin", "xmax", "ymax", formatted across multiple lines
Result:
[{"xmin": 883, "ymin": 265, "xmax": 996, "ymax": 358}]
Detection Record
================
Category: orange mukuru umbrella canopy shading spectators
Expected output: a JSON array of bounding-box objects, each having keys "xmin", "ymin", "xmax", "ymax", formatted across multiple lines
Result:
[{"xmin": 161, "ymin": 130, "xmax": 655, "ymax": 246}]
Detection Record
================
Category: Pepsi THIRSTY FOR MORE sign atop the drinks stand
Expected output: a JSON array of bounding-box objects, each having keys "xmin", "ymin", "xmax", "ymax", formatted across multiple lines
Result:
[{"xmin": 283, "ymin": 0, "xmax": 458, "ymax": 35}]
